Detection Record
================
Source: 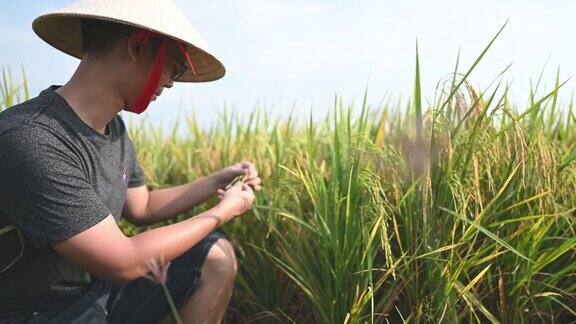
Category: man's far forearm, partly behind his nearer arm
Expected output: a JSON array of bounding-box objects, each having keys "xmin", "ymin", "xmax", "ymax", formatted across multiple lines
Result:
[{"xmin": 122, "ymin": 174, "xmax": 222, "ymax": 226}]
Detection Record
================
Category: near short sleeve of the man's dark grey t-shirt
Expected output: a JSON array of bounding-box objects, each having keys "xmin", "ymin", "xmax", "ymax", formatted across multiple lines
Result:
[{"xmin": 0, "ymin": 128, "xmax": 110, "ymax": 247}]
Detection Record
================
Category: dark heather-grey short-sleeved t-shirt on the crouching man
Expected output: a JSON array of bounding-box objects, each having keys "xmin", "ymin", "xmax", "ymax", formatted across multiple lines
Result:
[{"xmin": 0, "ymin": 85, "xmax": 145, "ymax": 314}]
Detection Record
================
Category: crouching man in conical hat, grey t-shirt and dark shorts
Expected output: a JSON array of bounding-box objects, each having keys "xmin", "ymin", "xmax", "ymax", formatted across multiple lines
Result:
[{"xmin": 0, "ymin": 0, "xmax": 261, "ymax": 323}]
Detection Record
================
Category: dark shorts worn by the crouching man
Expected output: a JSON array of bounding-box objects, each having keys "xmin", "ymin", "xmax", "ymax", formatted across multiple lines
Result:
[{"xmin": 0, "ymin": 232, "xmax": 223, "ymax": 324}]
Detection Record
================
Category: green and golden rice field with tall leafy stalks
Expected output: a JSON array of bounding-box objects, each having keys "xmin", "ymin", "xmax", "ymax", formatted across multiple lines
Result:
[{"xmin": 0, "ymin": 32, "xmax": 576, "ymax": 323}]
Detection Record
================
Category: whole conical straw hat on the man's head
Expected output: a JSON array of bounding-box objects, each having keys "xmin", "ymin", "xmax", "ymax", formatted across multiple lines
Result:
[{"xmin": 32, "ymin": 0, "xmax": 226, "ymax": 82}]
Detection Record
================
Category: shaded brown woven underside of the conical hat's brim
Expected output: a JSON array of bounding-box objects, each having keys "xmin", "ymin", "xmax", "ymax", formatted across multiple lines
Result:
[{"xmin": 32, "ymin": 13, "xmax": 226, "ymax": 82}]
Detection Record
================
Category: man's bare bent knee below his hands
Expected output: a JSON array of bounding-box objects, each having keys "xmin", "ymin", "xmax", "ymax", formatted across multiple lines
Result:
[{"xmin": 202, "ymin": 238, "xmax": 238, "ymax": 282}]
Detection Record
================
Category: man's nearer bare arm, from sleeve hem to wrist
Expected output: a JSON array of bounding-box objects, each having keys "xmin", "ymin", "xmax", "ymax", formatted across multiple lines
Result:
[{"xmin": 52, "ymin": 204, "xmax": 234, "ymax": 284}]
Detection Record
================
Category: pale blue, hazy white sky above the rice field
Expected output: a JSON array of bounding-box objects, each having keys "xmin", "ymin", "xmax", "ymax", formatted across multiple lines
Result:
[{"xmin": 0, "ymin": 0, "xmax": 576, "ymax": 129}]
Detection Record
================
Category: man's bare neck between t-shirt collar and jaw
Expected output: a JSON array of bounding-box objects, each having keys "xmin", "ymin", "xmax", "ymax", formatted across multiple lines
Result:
[{"xmin": 55, "ymin": 62, "xmax": 124, "ymax": 134}]
